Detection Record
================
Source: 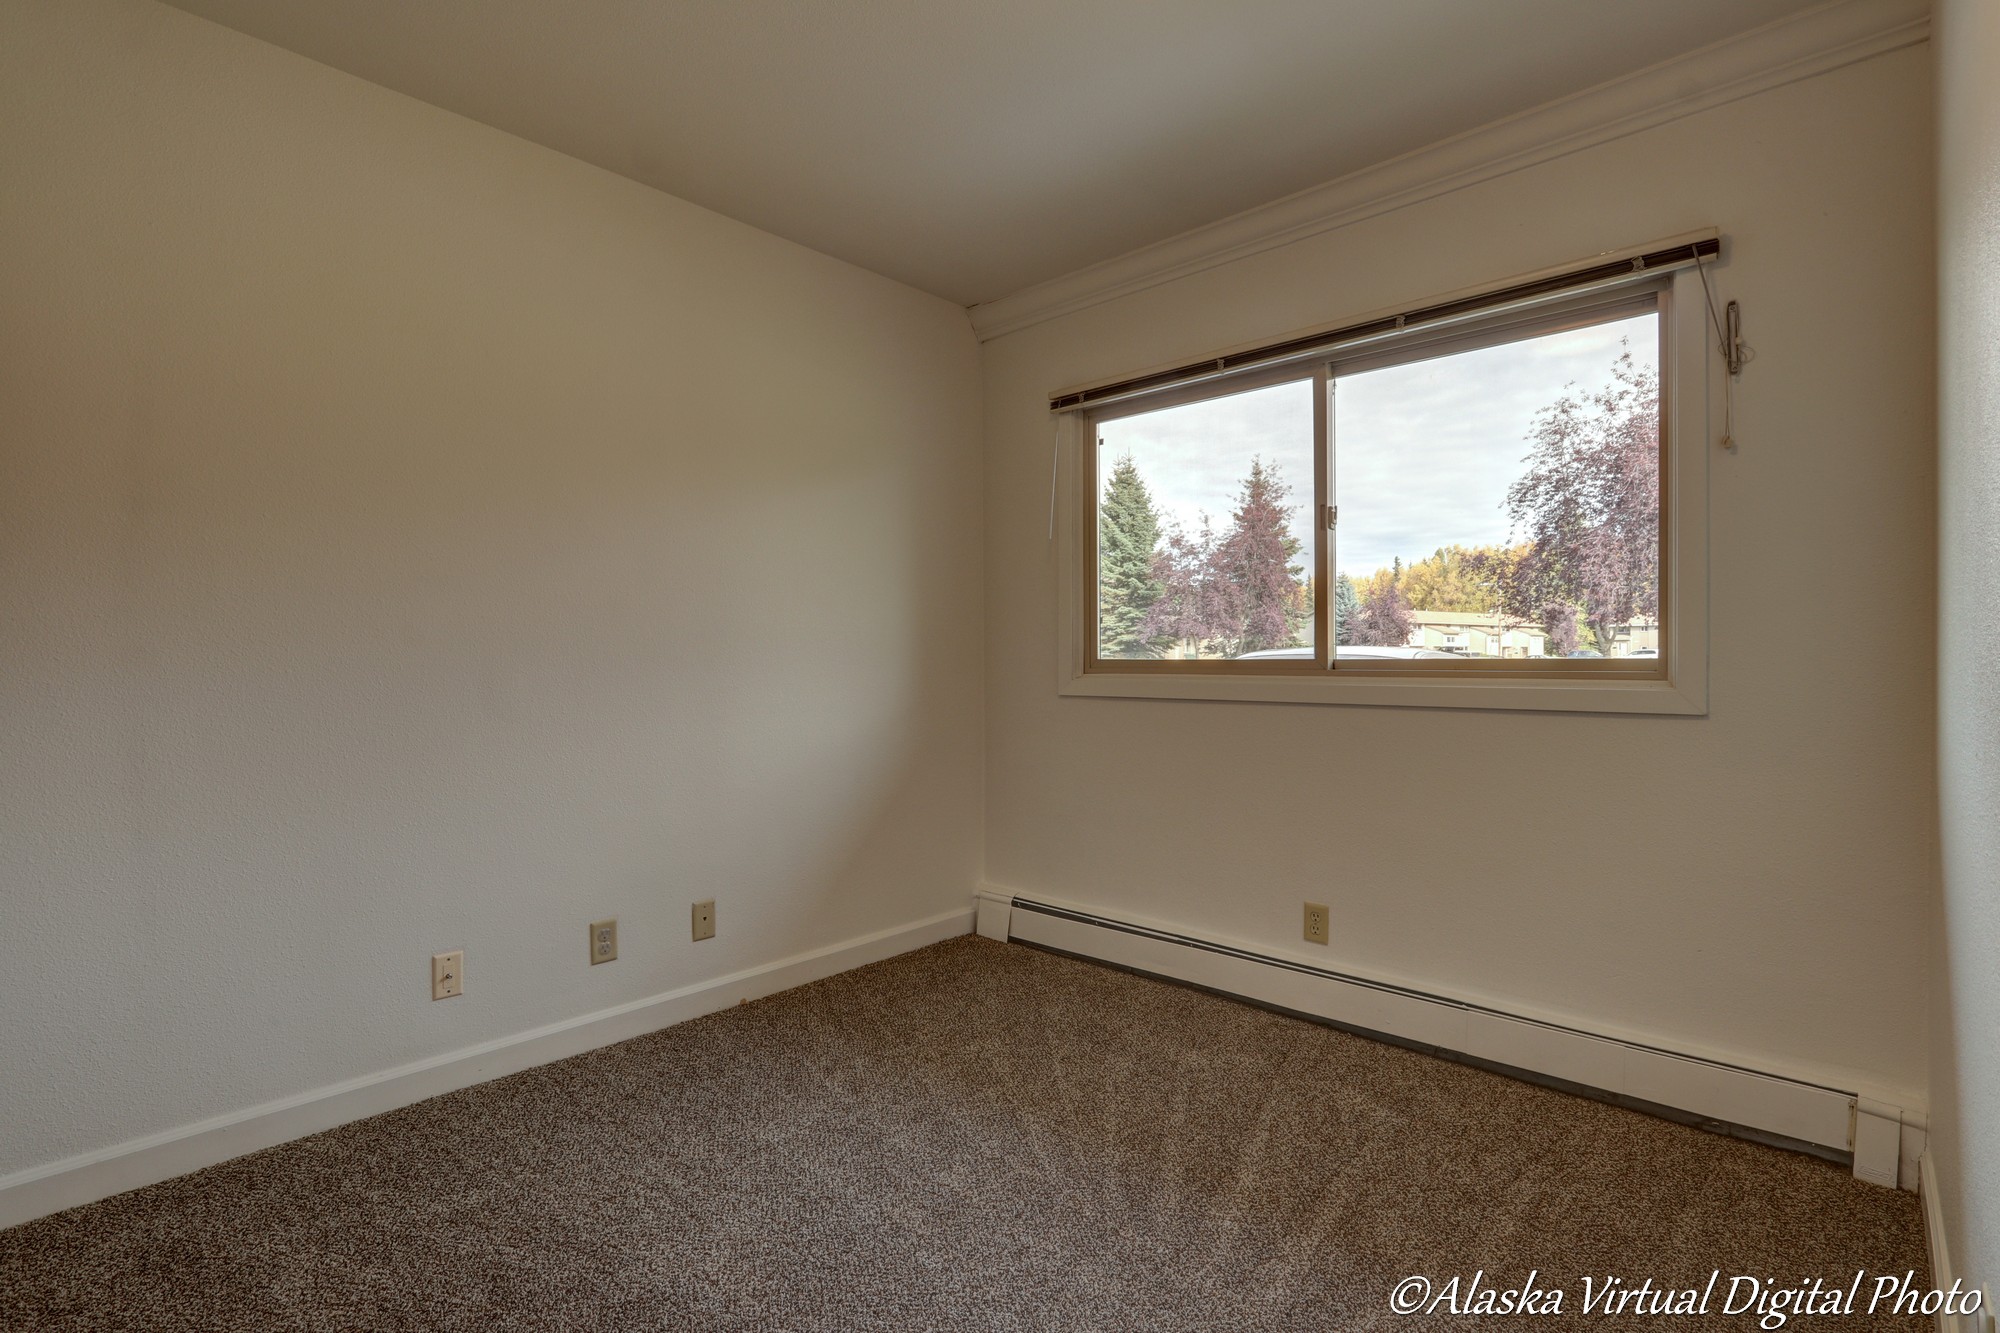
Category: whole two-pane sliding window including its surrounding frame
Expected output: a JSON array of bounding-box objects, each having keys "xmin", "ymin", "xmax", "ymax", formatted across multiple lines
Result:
[{"xmin": 1064, "ymin": 240, "xmax": 1706, "ymax": 713}]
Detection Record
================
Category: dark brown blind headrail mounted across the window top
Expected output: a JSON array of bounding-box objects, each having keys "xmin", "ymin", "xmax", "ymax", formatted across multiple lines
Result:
[{"xmin": 1048, "ymin": 236, "xmax": 1722, "ymax": 412}]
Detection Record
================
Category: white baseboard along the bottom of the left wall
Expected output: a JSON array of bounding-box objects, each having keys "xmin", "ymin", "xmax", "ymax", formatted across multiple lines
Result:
[{"xmin": 0, "ymin": 907, "xmax": 974, "ymax": 1229}]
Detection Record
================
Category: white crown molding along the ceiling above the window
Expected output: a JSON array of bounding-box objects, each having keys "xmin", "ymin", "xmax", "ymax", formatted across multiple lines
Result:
[{"xmin": 970, "ymin": 0, "xmax": 1930, "ymax": 342}]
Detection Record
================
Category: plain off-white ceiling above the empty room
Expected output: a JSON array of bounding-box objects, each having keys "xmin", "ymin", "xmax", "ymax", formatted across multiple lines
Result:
[{"xmin": 172, "ymin": 0, "xmax": 1832, "ymax": 304}]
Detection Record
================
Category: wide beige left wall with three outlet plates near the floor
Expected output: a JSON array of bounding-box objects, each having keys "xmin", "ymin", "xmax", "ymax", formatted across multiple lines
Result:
[{"xmin": 0, "ymin": 0, "xmax": 982, "ymax": 1175}]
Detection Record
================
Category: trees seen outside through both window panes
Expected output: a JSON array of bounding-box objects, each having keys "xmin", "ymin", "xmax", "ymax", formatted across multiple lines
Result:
[{"xmin": 1098, "ymin": 350, "xmax": 1660, "ymax": 658}]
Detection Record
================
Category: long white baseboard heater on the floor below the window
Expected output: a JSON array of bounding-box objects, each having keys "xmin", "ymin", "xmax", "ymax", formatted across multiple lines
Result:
[{"xmin": 978, "ymin": 893, "xmax": 1922, "ymax": 1189}]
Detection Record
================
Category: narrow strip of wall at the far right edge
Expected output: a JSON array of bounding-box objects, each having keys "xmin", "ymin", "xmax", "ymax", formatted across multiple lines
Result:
[{"xmin": 1930, "ymin": 0, "xmax": 2000, "ymax": 1291}]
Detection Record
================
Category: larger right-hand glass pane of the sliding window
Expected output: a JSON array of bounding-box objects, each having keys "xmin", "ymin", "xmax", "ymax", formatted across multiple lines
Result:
[{"xmin": 1332, "ymin": 310, "xmax": 1660, "ymax": 664}]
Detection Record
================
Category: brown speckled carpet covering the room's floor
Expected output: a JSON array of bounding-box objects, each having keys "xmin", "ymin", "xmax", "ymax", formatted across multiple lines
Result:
[{"xmin": 0, "ymin": 937, "xmax": 1928, "ymax": 1333}]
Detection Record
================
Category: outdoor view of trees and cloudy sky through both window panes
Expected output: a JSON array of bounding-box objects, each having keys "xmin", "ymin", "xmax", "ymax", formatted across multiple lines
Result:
[{"xmin": 1094, "ymin": 298, "xmax": 1660, "ymax": 671}]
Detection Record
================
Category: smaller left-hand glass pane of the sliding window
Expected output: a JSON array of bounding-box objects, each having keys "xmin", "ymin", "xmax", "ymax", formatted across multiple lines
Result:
[{"xmin": 1096, "ymin": 378, "xmax": 1314, "ymax": 658}]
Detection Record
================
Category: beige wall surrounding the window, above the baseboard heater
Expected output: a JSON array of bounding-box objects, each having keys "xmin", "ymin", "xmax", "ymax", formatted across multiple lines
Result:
[{"xmin": 984, "ymin": 48, "xmax": 1936, "ymax": 1107}]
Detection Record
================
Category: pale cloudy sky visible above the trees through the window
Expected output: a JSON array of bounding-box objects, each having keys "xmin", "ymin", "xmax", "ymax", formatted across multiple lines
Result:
[{"xmin": 1098, "ymin": 314, "xmax": 1658, "ymax": 578}]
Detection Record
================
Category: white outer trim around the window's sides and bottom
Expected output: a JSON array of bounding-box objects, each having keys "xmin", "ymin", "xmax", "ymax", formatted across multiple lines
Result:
[{"xmin": 1054, "ymin": 252, "xmax": 1720, "ymax": 715}]
